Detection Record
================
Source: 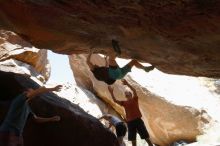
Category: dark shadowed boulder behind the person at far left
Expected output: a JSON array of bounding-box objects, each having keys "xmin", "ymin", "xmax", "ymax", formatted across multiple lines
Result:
[{"xmin": 0, "ymin": 66, "xmax": 118, "ymax": 146}]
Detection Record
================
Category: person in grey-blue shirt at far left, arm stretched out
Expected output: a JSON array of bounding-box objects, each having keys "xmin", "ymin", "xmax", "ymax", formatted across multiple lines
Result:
[{"xmin": 0, "ymin": 85, "xmax": 62, "ymax": 146}]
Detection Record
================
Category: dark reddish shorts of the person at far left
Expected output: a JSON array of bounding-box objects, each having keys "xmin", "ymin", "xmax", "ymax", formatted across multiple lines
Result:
[{"xmin": 0, "ymin": 132, "xmax": 23, "ymax": 146}]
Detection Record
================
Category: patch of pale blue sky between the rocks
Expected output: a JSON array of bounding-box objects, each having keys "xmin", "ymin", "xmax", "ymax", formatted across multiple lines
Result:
[{"xmin": 47, "ymin": 51, "xmax": 75, "ymax": 84}]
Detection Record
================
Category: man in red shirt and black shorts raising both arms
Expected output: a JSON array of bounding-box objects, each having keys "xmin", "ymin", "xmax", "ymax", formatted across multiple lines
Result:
[{"xmin": 108, "ymin": 79, "xmax": 153, "ymax": 146}]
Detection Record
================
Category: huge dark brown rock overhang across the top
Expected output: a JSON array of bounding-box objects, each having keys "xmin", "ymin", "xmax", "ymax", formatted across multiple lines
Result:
[{"xmin": 0, "ymin": 0, "xmax": 220, "ymax": 77}]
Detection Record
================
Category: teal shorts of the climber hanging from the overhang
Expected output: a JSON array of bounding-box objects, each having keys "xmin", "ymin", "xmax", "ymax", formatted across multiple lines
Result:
[{"xmin": 108, "ymin": 65, "xmax": 131, "ymax": 80}]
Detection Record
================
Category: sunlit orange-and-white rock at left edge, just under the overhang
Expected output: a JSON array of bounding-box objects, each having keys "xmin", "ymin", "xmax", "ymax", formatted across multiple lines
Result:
[{"xmin": 0, "ymin": 30, "xmax": 50, "ymax": 81}]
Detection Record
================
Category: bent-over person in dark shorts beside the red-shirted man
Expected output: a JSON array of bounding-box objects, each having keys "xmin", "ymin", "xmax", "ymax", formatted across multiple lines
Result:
[{"xmin": 99, "ymin": 114, "xmax": 127, "ymax": 146}]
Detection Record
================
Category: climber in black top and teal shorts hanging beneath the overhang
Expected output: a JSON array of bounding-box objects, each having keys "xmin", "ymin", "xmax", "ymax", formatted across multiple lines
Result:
[{"xmin": 87, "ymin": 40, "xmax": 154, "ymax": 85}]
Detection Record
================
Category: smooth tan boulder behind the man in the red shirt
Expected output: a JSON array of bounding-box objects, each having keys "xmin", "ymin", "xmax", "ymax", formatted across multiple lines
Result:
[{"xmin": 69, "ymin": 55, "xmax": 210, "ymax": 146}]
